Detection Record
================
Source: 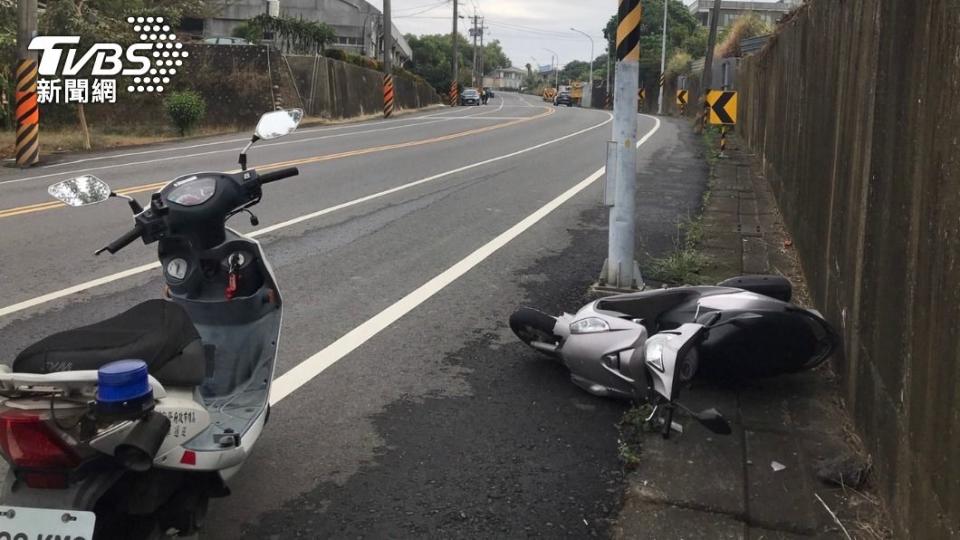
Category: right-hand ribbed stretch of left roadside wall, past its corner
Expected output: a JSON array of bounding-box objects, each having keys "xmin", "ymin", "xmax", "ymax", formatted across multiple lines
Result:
[{"xmin": 287, "ymin": 55, "xmax": 440, "ymax": 118}]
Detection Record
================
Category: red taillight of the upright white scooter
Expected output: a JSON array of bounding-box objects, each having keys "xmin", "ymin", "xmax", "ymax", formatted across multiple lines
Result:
[{"xmin": 0, "ymin": 410, "xmax": 80, "ymax": 472}]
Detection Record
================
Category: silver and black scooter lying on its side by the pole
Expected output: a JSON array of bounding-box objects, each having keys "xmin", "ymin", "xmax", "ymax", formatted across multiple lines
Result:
[{"xmin": 510, "ymin": 276, "xmax": 840, "ymax": 435}]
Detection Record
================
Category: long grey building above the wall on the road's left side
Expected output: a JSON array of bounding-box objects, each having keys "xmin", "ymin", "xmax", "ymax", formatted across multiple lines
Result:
[{"xmin": 202, "ymin": 0, "xmax": 413, "ymax": 66}]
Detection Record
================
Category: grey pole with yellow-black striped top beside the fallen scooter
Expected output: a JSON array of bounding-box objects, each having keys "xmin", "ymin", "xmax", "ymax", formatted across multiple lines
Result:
[{"xmin": 601, "ymin": 0, "xmax": 643, "ymax": 289}]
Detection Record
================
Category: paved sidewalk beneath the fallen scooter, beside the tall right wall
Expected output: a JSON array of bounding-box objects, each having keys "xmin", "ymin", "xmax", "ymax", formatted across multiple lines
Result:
[{"xmin": 612, "ymin": 132, "xmax": 884, "ymax": 540}]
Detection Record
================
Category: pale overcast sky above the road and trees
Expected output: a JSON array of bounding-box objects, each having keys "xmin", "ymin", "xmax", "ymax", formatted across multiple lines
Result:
[{"xmin": 368, "ymin": 0, "xmax": 792, "ymax": 70}]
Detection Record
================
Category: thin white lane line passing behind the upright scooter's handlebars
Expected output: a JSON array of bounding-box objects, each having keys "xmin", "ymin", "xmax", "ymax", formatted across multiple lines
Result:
[{"xmin": 0, "ymin": 113, "xmax": 616, "ymax": 317}]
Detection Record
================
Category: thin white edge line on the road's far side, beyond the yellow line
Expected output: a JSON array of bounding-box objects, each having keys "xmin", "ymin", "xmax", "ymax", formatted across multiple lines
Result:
[{"xmin": 0, "ymin": 111, "xmax": 506, "ymax": 186}]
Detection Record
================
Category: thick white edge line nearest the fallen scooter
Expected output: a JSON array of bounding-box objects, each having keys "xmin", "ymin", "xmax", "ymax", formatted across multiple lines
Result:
[{"xmin": 270, "ymin": 118, "xmax": 660, "ymax": 405}]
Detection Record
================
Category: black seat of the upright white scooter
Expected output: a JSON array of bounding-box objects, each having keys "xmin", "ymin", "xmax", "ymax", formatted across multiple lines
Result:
[{"xmin": 12, "ymin": 300, "xmax": 206, "ymax": 386}]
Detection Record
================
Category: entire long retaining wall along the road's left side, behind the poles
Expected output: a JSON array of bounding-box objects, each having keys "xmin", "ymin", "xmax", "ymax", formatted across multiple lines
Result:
[{"xmin": 40, "ymin": 44, "xmax": 440, "ymax": 133}]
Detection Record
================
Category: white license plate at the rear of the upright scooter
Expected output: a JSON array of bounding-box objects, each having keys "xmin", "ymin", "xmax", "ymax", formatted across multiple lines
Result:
[{"xmin": 0, "ymin": 506, "xmax": 96, "ymax": 540}]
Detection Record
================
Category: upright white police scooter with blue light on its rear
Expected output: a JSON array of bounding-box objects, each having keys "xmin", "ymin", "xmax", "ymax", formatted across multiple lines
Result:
[{"xmin": 0, "ymin": 109, "xmax": 303, "ymax": 540}]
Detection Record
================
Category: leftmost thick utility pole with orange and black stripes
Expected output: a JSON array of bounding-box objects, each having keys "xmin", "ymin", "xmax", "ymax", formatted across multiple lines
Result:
[{"xmin": 14, "ymin": 0, "xmax": 40, "ymax": 167}]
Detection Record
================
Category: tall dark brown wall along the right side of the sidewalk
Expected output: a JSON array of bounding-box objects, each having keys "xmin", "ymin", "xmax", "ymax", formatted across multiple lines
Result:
[{"xmin": 738, "ymin": 0, "xmax": 960, "ymax": 538}]
